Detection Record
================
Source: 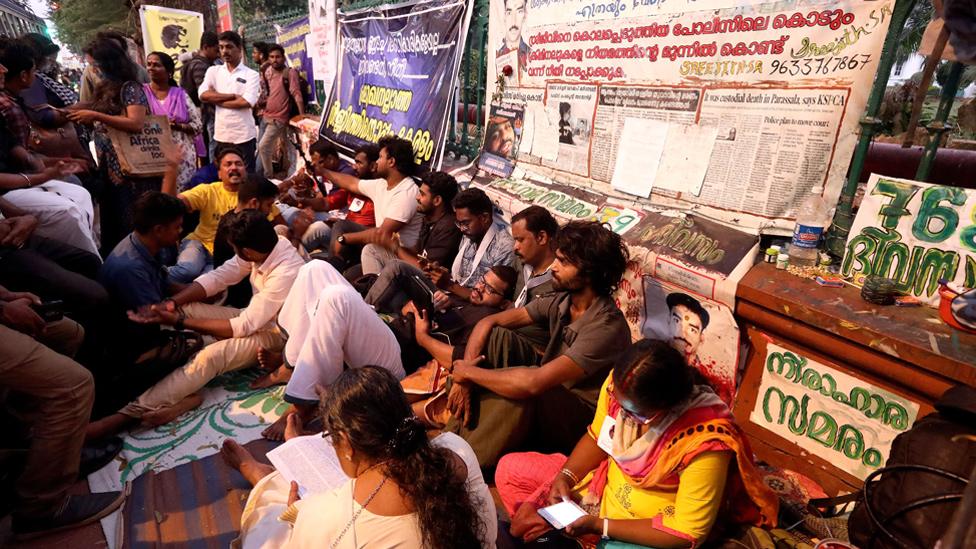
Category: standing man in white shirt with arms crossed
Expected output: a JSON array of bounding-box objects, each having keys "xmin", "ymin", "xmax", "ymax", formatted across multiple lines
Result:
[{"xmin": 199, "ymin": 31, "xmax": 261, "ymax": 173}]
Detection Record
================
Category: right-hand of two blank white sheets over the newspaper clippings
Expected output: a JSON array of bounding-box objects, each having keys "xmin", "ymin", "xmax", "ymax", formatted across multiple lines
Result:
[{"xmin": 654, "ymin": 124, "xmax": 718, "ymax": 196}]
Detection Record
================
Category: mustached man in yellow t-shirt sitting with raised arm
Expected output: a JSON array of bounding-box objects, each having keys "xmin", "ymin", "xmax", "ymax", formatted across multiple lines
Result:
[{"xmin": 169, "ymin": 147, "xmax": 284, "ymax": 284}]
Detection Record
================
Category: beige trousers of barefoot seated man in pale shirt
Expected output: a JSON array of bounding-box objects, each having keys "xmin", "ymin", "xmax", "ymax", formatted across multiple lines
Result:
[{"xmin": 119, "ymin": 303, "xmax": 284, "ymax": 418}]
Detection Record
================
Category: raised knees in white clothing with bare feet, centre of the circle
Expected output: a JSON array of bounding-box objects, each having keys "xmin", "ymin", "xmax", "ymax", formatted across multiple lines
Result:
[{"xmin": 255, "ymin": 260, "xmax": 404, "ymax": 440}]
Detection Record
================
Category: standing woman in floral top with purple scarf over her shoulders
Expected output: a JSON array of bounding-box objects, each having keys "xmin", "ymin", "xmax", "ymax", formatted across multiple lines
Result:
[{"xmin": 142, "ymin": 51, "xmax": 201, "ymax": 192}]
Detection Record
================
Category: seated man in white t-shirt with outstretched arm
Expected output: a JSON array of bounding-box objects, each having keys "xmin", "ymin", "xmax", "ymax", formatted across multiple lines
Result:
[{"xmin": 312, "ymin": 135, "xmax": 423, "ymax": 263}]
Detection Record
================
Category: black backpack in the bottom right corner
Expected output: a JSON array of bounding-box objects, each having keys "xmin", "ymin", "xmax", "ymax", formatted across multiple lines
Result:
[{"xmin": 848, "ymin": 385, "xmax": 976, "ymax": 549}]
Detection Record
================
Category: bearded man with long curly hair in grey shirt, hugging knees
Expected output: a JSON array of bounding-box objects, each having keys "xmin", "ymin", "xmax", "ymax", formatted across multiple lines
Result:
[{"xmin": 447, "ymin": 221, "xmax": 631, "ymax": 467}]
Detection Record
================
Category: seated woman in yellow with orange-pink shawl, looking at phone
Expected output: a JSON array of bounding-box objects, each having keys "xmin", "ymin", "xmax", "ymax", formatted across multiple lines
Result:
[{"xmin": 495, "ymin": 339, "xmax": 778, "ymax": 549}]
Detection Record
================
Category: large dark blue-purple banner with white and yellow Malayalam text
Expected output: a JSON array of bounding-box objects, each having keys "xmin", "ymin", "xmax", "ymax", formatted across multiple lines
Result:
[{"xmin": 320, "ymin": 0, "xmax": 471, "ymax": 169}]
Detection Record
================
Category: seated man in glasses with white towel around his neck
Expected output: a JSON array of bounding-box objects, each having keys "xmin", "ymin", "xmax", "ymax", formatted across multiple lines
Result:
[{"xmin": 363, "ymin": 185, "xmax": 514, "ymax": 311}]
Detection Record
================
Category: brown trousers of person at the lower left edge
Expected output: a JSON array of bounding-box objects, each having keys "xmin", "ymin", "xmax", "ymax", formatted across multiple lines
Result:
[{"xmin": 0, "ymin": 319, "xmax": 95, "ymax": 517}]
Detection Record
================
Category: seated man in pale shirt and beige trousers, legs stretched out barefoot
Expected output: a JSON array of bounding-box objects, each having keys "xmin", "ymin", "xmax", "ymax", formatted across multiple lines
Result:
[{"xmin": 88, "ymin": 210, "xmax": 305, "ymax": 439}]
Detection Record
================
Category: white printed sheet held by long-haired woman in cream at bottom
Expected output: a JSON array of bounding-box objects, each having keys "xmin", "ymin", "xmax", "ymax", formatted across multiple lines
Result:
[{"xmin": 268, "ymin": 434, "xmax": 349, "ymax": 497}]
